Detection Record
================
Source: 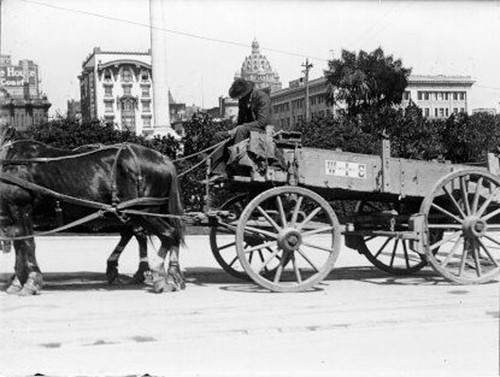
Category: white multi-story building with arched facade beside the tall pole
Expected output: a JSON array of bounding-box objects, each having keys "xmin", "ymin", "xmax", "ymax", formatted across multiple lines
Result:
[{"xmin": 79, "ymin": 47, "xmax": 153, "ymax": 135}]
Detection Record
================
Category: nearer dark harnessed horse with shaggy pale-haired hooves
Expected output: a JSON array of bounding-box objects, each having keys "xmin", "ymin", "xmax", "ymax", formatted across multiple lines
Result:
[{"xmin": 0, "ymin": 137, "xmax": 185, "ymax": 295}]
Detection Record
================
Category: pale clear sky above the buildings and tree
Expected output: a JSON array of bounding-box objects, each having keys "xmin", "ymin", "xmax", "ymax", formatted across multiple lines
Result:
[{"xmin": 0, "ymin": 0, "xmax": 500, "ymax": 115}]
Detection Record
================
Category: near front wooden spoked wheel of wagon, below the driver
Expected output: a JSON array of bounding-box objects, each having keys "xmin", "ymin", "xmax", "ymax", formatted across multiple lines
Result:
[{"xmin": 236, "ymin": 186, "xmax": 340, "ymax": 292}]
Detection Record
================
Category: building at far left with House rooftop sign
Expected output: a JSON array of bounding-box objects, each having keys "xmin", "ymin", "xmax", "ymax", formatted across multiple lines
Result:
[{"xmin": 0, "ymin": 55, "xmax": 51, "ymax": 131}]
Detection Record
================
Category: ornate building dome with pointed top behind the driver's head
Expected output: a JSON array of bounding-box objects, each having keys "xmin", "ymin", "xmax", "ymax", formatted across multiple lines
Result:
[{"xmin": 234, "ymin": 40, "xmax": 281, "ymax": 92}]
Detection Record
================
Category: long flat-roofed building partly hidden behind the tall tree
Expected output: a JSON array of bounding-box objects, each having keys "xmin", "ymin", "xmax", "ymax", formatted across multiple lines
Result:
[{"xmin": 271, "ymin": 75, "xmax": 474, "ymax": 129}]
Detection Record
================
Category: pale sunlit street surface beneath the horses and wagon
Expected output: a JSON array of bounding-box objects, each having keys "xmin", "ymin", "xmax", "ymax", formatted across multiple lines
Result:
[{"xmin": 0, "ymin": 236, "xmax": 499, "ymax": 376}]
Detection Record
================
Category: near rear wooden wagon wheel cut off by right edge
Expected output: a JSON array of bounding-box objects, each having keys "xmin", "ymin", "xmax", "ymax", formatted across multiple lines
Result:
[{"xmin": 420, "ymin": 170, "xmax": 500, "ymax": 284}]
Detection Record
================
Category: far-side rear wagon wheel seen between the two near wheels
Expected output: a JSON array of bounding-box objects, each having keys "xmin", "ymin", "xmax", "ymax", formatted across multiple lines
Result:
[{"xmin": 356, "ymin": 201, "xmax": 442, "ymax": 275}]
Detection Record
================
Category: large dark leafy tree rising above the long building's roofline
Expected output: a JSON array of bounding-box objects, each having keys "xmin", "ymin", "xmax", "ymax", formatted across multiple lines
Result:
[{"xmin": 325, "ymin": 47, "xmax": 411, "ymax": 115}]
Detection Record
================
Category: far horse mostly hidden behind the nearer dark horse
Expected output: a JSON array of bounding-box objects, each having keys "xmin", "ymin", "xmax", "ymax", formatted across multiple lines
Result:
[{"xmin": 1, "ymin": 139, "xmax": 150, "ymax": 284}]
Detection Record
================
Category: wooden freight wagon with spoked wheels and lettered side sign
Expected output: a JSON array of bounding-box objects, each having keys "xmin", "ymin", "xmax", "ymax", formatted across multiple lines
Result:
[{"xmin": 209, "ymin": 129, "xmax": 500, "ymax": 292}]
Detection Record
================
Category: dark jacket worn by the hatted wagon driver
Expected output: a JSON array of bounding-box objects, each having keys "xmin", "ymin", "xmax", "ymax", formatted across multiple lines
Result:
[{"xmin": 238, "ymin": 89, "xmax": 271, "ymax": 130}]
